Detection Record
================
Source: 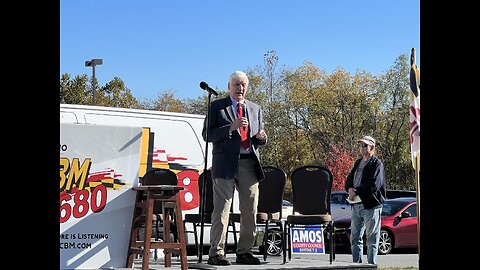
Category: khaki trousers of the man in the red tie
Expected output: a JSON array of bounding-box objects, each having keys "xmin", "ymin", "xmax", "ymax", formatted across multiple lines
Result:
[{"xmin": 209, "ymin": 158, "xmax": 258, "ymax": 257}]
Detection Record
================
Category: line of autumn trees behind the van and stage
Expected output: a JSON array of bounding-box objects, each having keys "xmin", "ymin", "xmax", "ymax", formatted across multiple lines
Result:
[{"xmin": 60, "ymin": 50, "xmax": 415, "ymax": 190}]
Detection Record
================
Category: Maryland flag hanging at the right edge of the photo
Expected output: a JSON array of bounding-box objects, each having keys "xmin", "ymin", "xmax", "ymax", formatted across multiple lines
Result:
[{"xmin": 408, "ymin": 48, "xmax": 420, "ymax": 170}]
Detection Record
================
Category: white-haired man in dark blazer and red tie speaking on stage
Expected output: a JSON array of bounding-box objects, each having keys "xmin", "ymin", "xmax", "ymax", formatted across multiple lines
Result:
[{"xmin": 202, "ymin": 71, "xmax": 267, "ymax": 265}]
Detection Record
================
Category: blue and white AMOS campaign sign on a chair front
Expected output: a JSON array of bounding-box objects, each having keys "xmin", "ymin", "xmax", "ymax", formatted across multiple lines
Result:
[{"xmin": 290, "ymin": 225, "xmax": 325, "ymax": 254}]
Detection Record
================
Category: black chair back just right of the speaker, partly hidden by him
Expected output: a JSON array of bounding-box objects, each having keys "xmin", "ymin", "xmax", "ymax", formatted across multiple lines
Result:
[{"xmin": 257, "ymin": 166, "xmax": 287, "ymax": 217}]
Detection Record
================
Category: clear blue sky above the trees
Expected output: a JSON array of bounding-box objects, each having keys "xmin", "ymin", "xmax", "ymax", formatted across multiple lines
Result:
[{"xmin": 59, "ymin": 0, "xmax": 421, "ymax": 100}]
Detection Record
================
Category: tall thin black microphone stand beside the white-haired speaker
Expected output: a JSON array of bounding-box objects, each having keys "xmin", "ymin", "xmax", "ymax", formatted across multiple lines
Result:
[{"xmin": 189, "ymin": 91, "xmax": 217, "ymax": 269}]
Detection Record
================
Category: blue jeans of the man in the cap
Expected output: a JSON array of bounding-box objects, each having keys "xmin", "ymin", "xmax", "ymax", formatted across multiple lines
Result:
[{"xmin": 350, "ymin": 203, "xmax": 382, "ymax": 264}]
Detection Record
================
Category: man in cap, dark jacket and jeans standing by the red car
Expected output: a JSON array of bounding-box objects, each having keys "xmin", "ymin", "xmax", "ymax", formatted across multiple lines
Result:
[{"xmin": 345, "ymin": 136, "xmax": 387, "ymax": 264}]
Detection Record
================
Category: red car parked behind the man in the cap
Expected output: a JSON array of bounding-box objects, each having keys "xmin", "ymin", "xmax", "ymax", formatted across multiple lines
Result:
[{"xmin": 334, "ymin": 197, "xmax": 418, "ymax": 255}]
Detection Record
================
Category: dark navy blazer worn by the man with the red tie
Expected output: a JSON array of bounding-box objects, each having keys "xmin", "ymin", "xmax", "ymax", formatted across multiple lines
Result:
[{"xmin": 202, "ymin": 96, "xmax": 267, "ymax": 181}]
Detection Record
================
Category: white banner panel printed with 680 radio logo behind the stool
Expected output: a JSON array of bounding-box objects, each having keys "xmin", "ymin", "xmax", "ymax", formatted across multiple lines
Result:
[{"xmin": 60, "ymin": 123, "xmax": 142, "ymax": 269}]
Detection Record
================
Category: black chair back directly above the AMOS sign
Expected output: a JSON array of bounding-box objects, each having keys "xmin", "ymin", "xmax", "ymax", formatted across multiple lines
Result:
[{"xmin": 290, "ymin": 165, "xmax": 333, "ymax": 215}]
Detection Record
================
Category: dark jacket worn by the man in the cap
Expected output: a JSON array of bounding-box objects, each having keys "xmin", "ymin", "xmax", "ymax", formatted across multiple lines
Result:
[{"xmin": 345, "ymin": 156, "xmax": 387, "ymax": 209}]
